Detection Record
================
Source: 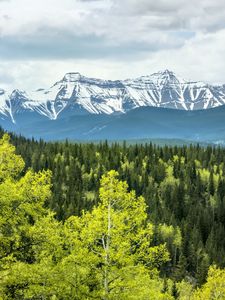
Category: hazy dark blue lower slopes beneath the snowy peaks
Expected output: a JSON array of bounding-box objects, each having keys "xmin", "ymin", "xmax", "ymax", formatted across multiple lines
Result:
[{"xmin": 0, "ymin": 106, "xmax": 225, "ymax": 144}]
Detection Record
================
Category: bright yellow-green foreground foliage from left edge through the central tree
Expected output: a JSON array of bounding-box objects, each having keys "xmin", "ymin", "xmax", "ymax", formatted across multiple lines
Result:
[{"xmin": 0, "ymin": 137, "xmax": 172, "ymax": 299}]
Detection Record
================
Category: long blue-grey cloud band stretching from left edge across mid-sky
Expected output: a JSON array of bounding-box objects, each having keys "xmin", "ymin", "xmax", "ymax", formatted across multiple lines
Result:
[{"xmin": 0, "ymin": 28, "xmax": 190, "ymax": 61}]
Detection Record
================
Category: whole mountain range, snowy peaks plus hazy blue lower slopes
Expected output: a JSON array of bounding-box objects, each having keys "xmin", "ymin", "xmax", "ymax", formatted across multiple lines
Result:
[{"xmin": 0, "ymin": 70, "xmax": 225, "ymax": 144}]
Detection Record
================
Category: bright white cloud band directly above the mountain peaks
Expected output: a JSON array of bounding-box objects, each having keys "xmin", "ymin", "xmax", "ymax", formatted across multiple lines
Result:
[{"xmin": 0, "ymin": 30, "xmax": 225, "ymax": 90}]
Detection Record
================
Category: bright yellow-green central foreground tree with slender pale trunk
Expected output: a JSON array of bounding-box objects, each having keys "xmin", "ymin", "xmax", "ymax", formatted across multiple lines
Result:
[{"xmin": 62, "ymin": 171, "xmax": 170, "ymax": 299}]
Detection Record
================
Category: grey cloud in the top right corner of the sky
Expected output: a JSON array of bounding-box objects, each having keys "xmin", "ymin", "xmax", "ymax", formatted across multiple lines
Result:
[{"xmin": 113, "ymin": 0, "xmax": 225, "ymax": 31}]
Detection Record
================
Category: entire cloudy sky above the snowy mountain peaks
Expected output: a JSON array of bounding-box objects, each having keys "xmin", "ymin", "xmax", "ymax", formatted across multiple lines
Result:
[{"xmin": 0, "ymin": 0, "xmax": 225, "ymax": 90}]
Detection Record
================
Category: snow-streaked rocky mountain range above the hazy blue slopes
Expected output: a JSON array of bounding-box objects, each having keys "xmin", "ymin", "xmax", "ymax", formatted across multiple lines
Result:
[{"xmin": 0, "ymin": 70, "xmax": 225, "ymax": 123}]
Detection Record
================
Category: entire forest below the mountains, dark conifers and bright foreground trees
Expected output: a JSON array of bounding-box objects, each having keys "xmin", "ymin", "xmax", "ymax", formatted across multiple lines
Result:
[{"xmin": 0, "ymin": 127, "xmax": 225, "ymax": 300}]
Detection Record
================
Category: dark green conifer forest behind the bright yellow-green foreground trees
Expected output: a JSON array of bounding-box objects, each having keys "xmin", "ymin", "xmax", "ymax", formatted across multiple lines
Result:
[{"xmin": 1, "ymin": 127, "xmax": 225, "ymax": 285}]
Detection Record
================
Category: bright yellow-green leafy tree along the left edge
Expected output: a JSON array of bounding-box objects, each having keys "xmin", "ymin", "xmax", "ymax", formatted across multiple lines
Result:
[{"xmin": 0, "ymin": 135, "xmax": 51, "ymax": 299}]
